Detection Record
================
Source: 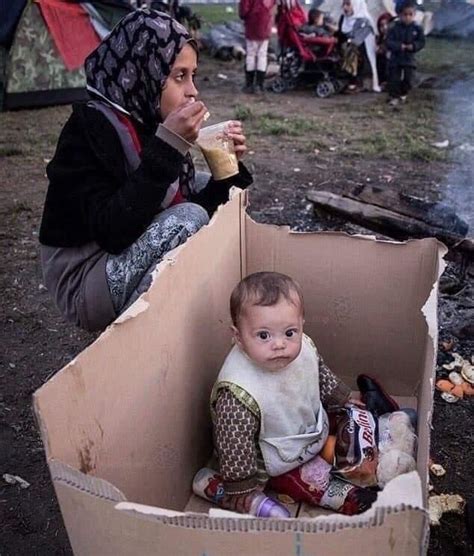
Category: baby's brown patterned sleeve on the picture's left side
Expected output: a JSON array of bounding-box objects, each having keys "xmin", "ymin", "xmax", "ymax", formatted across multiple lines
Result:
[{"xmin": 213, "ymin": 388, "xmax": 260, "ymax": 494}]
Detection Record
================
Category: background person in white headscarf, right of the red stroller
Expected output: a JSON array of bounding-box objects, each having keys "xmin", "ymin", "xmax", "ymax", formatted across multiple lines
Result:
[{"xmin": 338, "ymin": 0, "xmax": 381, "ymax": 93}]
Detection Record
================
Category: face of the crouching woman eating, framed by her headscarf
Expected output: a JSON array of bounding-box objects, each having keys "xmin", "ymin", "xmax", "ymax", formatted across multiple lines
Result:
[{"xmin": 160, "ymin": 44, "xmax": 199, "ymax": 121}]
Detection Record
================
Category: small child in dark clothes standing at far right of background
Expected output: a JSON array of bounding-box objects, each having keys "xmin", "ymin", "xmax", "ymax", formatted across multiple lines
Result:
[{"xmin": 387, "ymin": 0, "xmax": 425, "ymax": 106}]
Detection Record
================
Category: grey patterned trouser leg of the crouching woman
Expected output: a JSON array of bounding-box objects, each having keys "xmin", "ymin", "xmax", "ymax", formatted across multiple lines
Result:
[{"xmin": 105, "ymin": 203, "xmax": 209, "ymax": 315}]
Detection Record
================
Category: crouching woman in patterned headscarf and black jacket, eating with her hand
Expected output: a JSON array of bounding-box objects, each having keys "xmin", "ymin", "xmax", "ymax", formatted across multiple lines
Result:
[{"xmin": 39, "ymin": 10, "xmax": 252, "ymax": 330}]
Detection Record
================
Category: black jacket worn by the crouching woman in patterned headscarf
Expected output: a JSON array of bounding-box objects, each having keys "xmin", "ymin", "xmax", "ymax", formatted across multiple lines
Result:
[{"xmin": 39, "ymin": 104, "xmax": 252, "ymax": 254}]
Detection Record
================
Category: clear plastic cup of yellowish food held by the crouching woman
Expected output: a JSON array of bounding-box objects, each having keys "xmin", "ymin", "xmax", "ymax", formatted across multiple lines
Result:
[{"xmin": 196, "ymin": 121, "xmax": 239, "ymax": 180}]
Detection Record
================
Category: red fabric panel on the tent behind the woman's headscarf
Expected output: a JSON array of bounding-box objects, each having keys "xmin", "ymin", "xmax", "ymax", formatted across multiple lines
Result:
[{"xmin": 38, "ymin": 0, "xmax": 100, "ymax": 70}]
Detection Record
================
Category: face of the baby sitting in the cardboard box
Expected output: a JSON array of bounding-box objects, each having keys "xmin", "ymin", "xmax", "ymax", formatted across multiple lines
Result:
[{"xmin": 234, "ymin": 295, "xmax": 304, "ymax": 372}]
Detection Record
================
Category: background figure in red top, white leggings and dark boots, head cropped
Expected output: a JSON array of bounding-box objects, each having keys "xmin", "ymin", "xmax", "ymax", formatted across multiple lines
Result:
[{"xmin": 239, "ymin": 0, "xmax": 275, "ymax": 93}]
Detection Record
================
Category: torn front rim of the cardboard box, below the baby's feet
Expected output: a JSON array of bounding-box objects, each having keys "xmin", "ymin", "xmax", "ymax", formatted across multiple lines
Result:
[{"xmin": 49, "ymin": 460, "xmax": 428, "ymax": 533}]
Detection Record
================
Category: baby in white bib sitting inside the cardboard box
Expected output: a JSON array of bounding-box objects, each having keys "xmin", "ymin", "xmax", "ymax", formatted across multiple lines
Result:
[{"xmin": 211, "ymin": 272, "xmax": 376, "ymax": 514}]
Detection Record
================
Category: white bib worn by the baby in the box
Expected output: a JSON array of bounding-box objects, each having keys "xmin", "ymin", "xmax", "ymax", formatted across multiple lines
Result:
[{"xmin": 216, "ymin": 336, "xmax": 329, "ymax": 477}]
